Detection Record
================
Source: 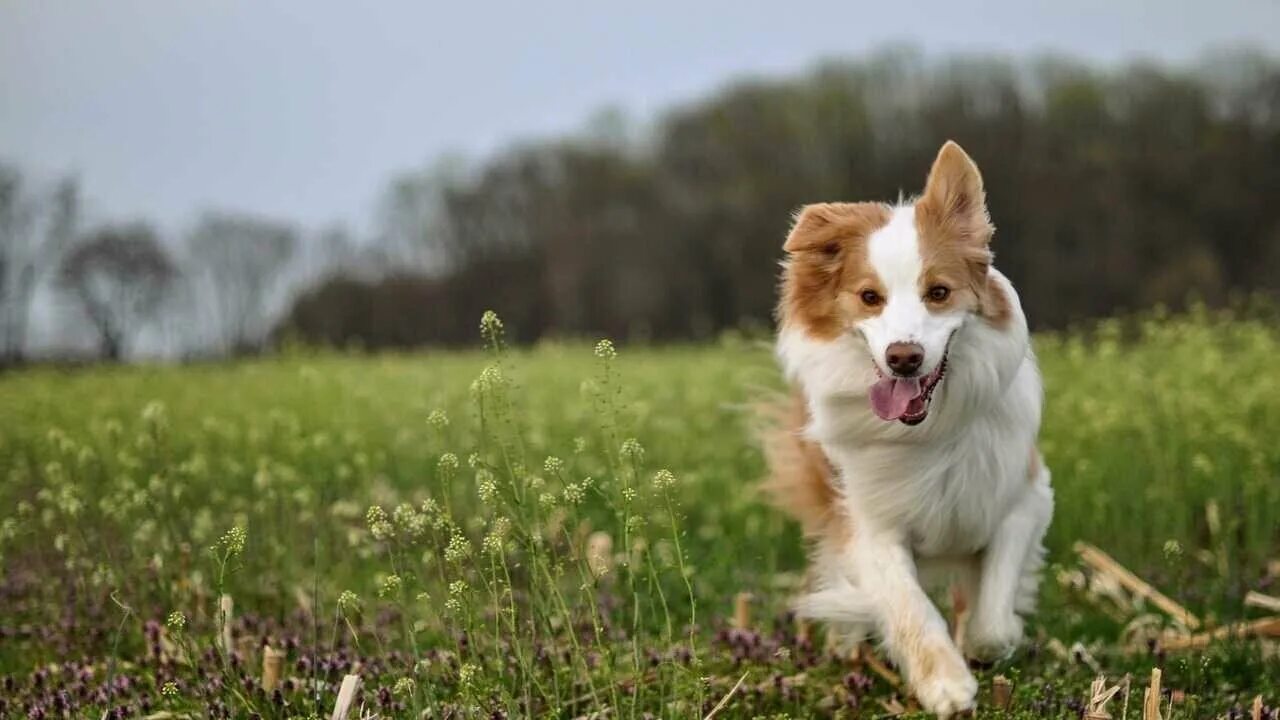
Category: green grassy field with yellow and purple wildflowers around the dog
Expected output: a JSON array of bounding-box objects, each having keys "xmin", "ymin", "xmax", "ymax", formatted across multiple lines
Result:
[{"xmin": 0, "ymin": 304, "xmax": 1280, "ymax": 717}]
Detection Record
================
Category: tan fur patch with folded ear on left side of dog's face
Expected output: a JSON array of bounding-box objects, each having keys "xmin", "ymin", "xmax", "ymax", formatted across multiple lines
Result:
[{"xmin": 778, "ymin": 202, "xmax": 892, "ymax": 340}]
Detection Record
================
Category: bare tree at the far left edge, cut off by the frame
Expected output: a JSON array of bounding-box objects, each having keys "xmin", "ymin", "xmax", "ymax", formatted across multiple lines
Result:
[{"xmin": 0, "ymin": 163, "xmax": 79, "ymax": 364}]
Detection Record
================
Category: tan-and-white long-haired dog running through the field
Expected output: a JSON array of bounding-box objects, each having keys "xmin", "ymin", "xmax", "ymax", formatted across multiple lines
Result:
[{"xmin": 765, "ymin": 141, "xmax": 1053, "ymax": 717}]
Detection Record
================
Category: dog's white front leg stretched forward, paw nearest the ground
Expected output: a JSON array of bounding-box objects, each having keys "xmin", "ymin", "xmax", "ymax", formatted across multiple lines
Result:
[{"xmin": 851, "ymin": 533, "xmax": 978, "ymax": 717}]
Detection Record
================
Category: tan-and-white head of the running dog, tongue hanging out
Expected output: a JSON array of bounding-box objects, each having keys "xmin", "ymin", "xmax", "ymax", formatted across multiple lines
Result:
[{"xmin": 781, "ymin": 142, "xmax": 1009, "ymax": 425}]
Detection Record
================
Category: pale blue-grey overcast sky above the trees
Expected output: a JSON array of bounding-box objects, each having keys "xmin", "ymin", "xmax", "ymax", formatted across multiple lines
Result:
[{"xmin": 0, "ymin": 0, "xmax": 1280, "ymax": 229}]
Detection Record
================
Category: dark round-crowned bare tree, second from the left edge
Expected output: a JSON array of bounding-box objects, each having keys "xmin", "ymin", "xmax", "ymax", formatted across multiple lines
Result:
[{"xmin": 60, "ymin": 223, "xmax": 177, "ymax": 360}]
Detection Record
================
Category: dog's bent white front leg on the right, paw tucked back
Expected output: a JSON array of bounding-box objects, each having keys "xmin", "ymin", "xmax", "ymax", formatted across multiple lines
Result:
[{"xmin": 964, "ymin": 468, "xmax": 1053, "ymax": 660}]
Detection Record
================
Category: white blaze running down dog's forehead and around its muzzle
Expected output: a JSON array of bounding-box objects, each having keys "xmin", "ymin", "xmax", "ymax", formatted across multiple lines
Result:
[{"xmin": 858, "ymin": 205, "xmax": 964, "ymax": 374}]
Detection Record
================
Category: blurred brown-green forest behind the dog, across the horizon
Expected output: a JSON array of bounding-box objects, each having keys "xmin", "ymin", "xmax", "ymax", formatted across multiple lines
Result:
[{"xmin": 0, "ymin": 51, "xmax": 1280, "ymax": 355}]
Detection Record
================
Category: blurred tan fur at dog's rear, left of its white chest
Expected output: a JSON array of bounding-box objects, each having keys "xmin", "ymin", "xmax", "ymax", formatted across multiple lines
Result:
[{"xmin": 760, "ymin": 391, "xmax": 846, "ymax": 541}]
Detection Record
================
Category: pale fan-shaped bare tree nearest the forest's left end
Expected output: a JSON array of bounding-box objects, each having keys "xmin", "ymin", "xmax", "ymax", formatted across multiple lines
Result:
[{"xmin": 188, "ymin": 213, "xmax": 297, "ymax": 352}]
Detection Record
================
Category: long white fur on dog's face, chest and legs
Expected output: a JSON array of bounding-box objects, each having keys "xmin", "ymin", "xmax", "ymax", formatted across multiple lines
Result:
[{"xmin": 777, "ymin": 205, "xmax": 1053, "ymax": 716}]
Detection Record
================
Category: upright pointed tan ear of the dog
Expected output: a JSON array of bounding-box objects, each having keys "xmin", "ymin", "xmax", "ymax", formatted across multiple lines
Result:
[{"xmin": 915, "ymin": 140, "xmax": 996, "ymax": 246}]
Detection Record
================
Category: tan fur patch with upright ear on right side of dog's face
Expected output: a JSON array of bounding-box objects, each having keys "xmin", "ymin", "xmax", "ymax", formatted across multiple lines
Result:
[{"xmin": 915, "ymin": 141, "xmax": 1012, "ymax": 327}]
